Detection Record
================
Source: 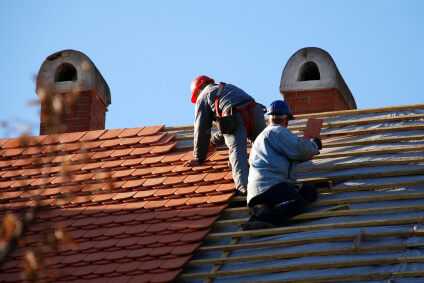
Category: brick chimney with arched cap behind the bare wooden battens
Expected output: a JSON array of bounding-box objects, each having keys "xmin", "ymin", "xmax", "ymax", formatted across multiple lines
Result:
[{"xmin": 280, "ymin": 47, "xmax": 356, "ymax": 115}]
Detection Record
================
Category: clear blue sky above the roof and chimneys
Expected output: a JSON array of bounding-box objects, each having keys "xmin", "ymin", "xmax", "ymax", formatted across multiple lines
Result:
[{"xmin": 0, "ymin": 0, "xmax": 424, "ymax": 138}]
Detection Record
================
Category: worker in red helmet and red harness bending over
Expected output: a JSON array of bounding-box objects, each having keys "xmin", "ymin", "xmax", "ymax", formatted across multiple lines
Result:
[{"xmin": 184, "ymin": 76, "xmax": 266, "ymax": 195}]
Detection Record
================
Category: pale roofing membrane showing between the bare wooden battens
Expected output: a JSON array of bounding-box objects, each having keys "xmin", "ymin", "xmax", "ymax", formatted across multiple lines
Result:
[{"xmin": 177, "ymin": 109, "xmax": 424, "ymax": 282}]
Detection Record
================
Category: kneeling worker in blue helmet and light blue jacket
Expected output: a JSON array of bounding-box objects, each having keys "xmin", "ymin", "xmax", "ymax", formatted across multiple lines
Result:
[{"xmin": 243, "ymin": 100, "xmax": 322, "ymax": 231}]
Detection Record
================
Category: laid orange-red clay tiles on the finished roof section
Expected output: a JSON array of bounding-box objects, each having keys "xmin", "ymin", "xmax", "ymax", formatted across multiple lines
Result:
[{"xmin": 0, "ymin": 126, "xmax": 235, "ymax": 282}]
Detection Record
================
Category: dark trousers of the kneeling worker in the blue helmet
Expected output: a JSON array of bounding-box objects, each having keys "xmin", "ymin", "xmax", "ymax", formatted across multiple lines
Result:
[{"xmin": 249, "ymin": 183, "xmax": 318, "ymax": 226}]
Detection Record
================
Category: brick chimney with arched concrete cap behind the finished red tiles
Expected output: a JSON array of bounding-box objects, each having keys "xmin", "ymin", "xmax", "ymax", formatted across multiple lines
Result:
[{"xmin": 36, "ymin": 50, "xmax": 111, "ymax": 135}]
